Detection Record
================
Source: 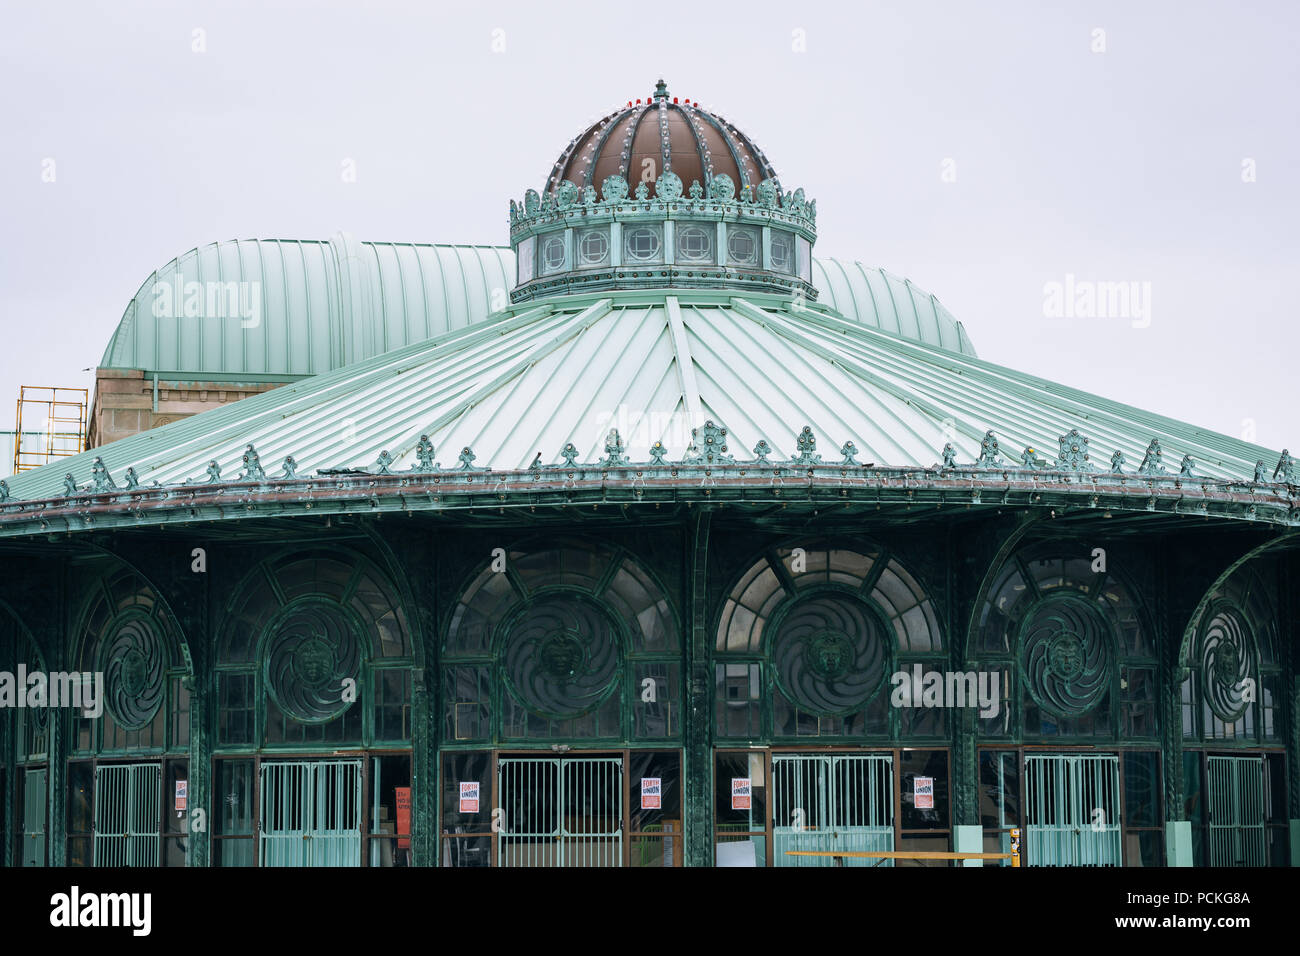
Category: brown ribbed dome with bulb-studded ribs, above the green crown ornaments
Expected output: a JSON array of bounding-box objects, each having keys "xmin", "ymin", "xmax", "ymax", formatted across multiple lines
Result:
[{"xmin": 542, "ymin": 79, "xmax": 777, "ymax": 200}]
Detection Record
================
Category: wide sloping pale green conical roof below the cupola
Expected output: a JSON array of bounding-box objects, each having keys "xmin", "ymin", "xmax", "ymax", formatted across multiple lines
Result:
[{"xmin": 9, "ymin": 290, "xmax": 1278, "ymax": 498}]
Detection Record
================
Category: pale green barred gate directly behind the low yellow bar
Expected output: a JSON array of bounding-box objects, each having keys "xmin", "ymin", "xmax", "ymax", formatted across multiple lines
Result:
[{"xmin": 772, "ymin": 754, "xmax": 894, "ymax": 866}]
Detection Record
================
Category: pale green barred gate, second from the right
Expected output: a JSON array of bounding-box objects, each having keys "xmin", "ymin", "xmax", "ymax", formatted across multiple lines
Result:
[{"xmin": 1024, "ymin": 753, "xmax": 1123, "ymax": 866}]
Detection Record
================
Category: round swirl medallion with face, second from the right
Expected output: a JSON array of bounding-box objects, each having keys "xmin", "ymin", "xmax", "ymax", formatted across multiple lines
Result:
[{"xmin": 1023, "ymin": 598, "xmax": 1110, "ymax": 717}]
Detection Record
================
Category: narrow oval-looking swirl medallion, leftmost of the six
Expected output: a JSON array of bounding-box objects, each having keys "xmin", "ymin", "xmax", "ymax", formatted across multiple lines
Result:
[{"xmin": 99, "ymin": 610, "xmax": 168, "ymax": 730}]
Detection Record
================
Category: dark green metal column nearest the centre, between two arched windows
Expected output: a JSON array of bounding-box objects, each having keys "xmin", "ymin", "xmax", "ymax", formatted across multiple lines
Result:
[{"xmin": 683, "ymin": 507, "xmax": 714, "ymax": 866}]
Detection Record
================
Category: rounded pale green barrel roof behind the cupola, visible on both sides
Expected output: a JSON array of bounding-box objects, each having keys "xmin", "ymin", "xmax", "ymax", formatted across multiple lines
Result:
[{"xmin": 100, "ymin": 233, "xmax": 975, "ymax": 378}]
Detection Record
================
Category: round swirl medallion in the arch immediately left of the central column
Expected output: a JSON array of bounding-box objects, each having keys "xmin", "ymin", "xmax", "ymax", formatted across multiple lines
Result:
[{"xmin": 502, "ymin": 594, "xmax": 623, "ymax": 719}]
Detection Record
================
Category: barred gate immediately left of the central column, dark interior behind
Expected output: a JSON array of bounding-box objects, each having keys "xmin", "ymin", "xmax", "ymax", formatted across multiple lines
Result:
[{"xmin": 497, "ymin": 757, "xmax": 623, "ymax": 866}]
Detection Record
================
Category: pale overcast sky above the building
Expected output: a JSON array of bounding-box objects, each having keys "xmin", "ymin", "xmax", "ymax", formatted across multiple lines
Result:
[{"xmin": 0, "ymin": 0, "xmax": 1300, "ymax": 473}]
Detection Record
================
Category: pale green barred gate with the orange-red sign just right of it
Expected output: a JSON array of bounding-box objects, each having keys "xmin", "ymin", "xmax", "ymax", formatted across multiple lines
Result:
[{"xmin": 260, "ymin": 760, "xmax": 361, "ymax": 866}]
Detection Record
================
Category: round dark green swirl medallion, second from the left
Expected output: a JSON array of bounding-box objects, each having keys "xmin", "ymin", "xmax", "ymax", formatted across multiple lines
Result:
[{"xmin": 267, "ymin": 598, "xmax": 361, "ymax": 723}]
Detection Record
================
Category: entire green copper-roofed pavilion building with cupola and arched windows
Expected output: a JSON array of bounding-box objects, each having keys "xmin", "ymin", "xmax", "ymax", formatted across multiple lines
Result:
[{"xmin": 0, "ymin": 81, "xmax": 1300, "ymax": 866}]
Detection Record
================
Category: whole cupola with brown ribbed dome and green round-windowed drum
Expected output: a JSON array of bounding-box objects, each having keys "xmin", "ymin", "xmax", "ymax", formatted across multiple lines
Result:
[{"xmin": 510, "ymin": 79, "xmax": 816, "ymax": 302}]
